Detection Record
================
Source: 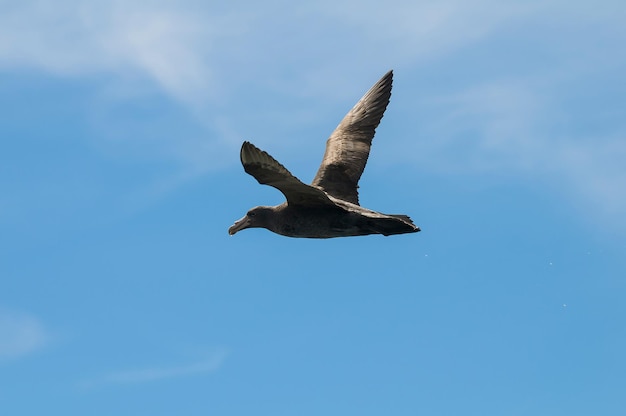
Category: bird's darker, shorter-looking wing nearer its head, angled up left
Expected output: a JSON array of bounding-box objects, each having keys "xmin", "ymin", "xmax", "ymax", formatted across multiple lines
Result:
[{"xmin": 240, "ymin": 142, "xmax": 335, "ymax": 206}]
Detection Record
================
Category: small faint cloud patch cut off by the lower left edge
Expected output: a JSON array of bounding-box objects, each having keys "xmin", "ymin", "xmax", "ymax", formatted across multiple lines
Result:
[{"xmin": 0, "ymin": 309, "xmax": 49, "ymax": 360}]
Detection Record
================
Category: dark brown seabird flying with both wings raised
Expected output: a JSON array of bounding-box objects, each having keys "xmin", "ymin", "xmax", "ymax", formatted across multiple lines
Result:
[{"xmin": 228, "ymin": 71, "xmax": 420, "ymax": 238}]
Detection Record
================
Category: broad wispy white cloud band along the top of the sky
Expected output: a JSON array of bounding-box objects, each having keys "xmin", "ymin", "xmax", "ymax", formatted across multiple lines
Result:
[{"xmin": 0, "ymin": 0, "xmax": 524, "ymax": 105}]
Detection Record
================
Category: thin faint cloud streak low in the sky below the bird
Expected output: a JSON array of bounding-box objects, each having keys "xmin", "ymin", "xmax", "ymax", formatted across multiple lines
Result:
[{"xmin": 80, "ymin": 349, "xmax": 228, "ymax": 388}]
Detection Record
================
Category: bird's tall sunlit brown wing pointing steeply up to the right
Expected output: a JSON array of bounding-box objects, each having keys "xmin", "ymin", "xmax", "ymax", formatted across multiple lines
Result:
[{"xmin": 311, "ymin": 71, "xmax": 393, "ymax": 205}]
